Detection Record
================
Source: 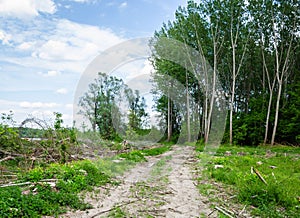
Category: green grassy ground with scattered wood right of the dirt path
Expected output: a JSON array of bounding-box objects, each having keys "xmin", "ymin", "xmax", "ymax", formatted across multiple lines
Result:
[{"xmin": 198, "ymin": 146, "xmax": 300, "ymax": 217}]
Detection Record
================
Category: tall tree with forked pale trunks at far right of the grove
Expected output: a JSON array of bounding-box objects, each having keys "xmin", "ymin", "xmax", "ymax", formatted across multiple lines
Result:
[{"xmin": 250, "ymin": 0, "xmax": 300, "ymax": 145}]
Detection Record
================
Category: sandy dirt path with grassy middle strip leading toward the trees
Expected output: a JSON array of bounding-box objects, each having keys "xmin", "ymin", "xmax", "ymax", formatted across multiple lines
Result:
[{"xmin": 62, "ymin": 146, "xmax": 213, "ymax": 218}]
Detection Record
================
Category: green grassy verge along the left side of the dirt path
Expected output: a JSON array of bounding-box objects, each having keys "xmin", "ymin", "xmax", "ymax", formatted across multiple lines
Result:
[{"xmin": 0, "ymin": 145, "xmax": 170, "ymax": 217}]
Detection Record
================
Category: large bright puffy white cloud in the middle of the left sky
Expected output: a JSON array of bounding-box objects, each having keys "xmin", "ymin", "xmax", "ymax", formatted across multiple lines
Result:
[{"xmin": 32, "ymin": 19, "xmax": 122, "ymax": 62}]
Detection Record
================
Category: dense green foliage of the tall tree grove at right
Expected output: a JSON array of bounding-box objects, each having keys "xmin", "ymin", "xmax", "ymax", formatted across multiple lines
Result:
[{"xmin": 151, "ymin": 0, "xmax": 300, "ymax": 146}]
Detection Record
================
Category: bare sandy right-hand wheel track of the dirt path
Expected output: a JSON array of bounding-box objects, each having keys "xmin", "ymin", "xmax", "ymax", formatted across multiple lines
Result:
[{"xmin": 159, "ymin": 146, "xmax": 211, "ymax": 218}]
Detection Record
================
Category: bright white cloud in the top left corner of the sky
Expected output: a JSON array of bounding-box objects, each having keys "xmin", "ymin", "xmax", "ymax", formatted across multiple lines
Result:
[{"xmin": 0, "ymin": 0, "xmax": 56, "ymax": 19}]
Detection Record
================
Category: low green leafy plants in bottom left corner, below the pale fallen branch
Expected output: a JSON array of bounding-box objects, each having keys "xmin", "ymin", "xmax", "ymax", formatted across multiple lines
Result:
[{"xmin": 0, "ymin": 184, "xmax": 89, "ymax": 217}]
